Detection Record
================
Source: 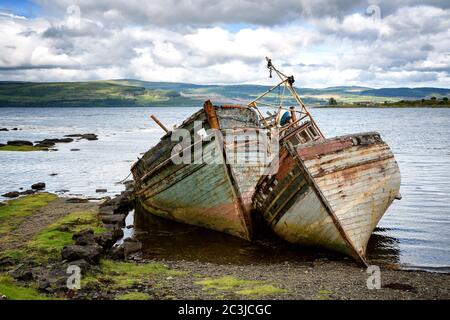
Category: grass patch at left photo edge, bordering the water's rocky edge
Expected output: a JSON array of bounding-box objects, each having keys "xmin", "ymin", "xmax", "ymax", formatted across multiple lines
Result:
[{"xmin": 0, "ymin": 193, "xmax": 57, "ymax": 234}]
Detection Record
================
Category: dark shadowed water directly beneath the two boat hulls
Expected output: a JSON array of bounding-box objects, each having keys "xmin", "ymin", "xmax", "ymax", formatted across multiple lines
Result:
[{"xmin": 134, "ymin": 208, "xmax": 399, "ymax": 265}]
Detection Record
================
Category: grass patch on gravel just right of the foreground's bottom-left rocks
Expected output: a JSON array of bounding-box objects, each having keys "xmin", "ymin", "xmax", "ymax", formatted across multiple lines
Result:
[{"xmin": 101, "ymin": 260, "xmax": 185, "ymax": 288}]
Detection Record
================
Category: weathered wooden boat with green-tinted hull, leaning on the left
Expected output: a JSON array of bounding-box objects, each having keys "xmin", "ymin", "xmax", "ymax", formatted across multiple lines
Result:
[{"xmin": 131, "ymin": 100, "xmax": 278, "ymax": 240}]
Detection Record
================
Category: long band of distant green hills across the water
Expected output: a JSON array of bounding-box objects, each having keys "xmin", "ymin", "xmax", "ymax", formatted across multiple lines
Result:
[{"xmin": 0, "ymin": 79, "xmax": 450, "ymax": 107}]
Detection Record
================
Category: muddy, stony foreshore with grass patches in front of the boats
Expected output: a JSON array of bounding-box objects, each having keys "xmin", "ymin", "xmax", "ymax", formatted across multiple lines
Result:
[{"xmin": 0, "ymin": 193, "xmax": 450, "ymax": 299}]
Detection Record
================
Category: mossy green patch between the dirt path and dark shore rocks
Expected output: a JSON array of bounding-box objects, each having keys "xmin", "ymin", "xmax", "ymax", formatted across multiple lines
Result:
[{"xmin": 28, "ymin": 210, "xmax": 106, "ymax": 258}]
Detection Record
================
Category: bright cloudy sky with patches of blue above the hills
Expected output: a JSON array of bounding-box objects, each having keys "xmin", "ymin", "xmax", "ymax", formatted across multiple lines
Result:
[{"xmin": 0, "ymin": 0, "xmax": 450, "ymax": 88}]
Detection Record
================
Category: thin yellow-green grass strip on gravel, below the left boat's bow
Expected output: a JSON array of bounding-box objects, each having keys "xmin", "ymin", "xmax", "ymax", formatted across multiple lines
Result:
[{"xmin": 194, "ymin": 276, "xmax": 285, "ymax": 296}]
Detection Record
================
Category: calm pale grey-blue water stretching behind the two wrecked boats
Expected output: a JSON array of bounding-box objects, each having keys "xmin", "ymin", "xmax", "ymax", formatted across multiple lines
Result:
[{"xmin": 0, "ymin": 108, "xmax": 450, "ymax": 271}]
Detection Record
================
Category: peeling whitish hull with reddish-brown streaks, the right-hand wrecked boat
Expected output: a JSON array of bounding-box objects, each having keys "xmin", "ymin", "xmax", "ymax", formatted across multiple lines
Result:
[{"xmin": 253, "ymin": 133, "xmax": 400, "ymax": 263}]
